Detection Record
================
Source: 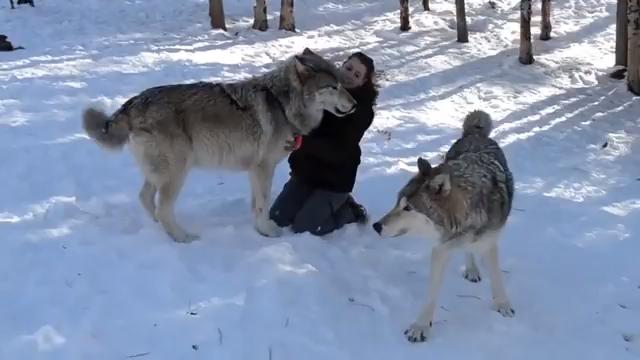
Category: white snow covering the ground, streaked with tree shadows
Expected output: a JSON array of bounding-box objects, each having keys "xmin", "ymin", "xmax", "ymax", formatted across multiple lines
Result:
[{"xmin": 0, "ymin": 0, "xmax": 640, "ymax": 360}]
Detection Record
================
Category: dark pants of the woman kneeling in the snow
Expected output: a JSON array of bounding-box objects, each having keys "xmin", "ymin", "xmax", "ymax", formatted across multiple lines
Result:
[{"xmin": 269, "ymin": 177, "xmax": 356, "ymax": 235}]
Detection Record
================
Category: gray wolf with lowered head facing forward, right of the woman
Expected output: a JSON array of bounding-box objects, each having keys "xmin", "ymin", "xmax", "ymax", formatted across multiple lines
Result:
[{"xmin": 373, "ymin": 111, "xmax": 515, "ymax": 342}]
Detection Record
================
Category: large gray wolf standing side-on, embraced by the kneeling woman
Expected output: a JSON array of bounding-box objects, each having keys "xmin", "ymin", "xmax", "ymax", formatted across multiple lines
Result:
[{"xmin": 83, "ymin": 49, "xmax": 356, "ymax": 242}]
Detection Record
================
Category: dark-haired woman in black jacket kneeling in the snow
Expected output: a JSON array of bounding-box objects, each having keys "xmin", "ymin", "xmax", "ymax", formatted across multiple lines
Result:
[{"xmin": 270, "ymin": 52, "xmax": 378, "ymax": 235}]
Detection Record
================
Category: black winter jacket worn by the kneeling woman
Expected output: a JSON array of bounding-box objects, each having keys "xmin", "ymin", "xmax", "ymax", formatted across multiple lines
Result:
[{"xmin": 289, "ymin": 103, "xmax": 374, "ymax": 193}]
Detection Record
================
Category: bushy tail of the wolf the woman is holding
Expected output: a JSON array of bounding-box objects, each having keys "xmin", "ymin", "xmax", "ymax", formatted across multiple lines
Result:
[{"xmin": 82, "ymin": 108, "xmax": 129, "ymax": 150}]
